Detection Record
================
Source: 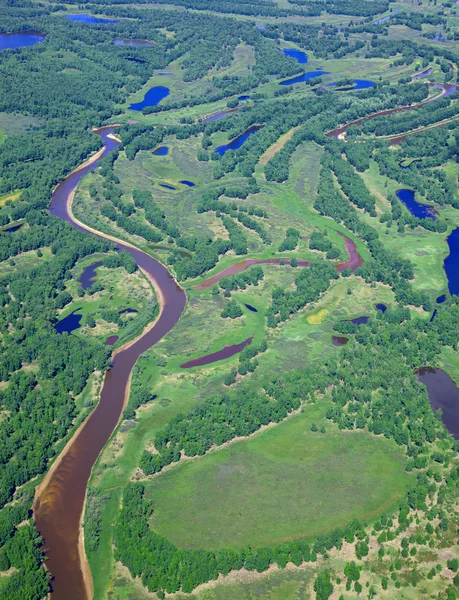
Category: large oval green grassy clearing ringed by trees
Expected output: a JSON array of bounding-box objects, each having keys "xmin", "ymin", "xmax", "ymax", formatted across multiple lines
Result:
[{"xmin": 146, "ymin": 402, "xmax": 411, "ymax": 550}]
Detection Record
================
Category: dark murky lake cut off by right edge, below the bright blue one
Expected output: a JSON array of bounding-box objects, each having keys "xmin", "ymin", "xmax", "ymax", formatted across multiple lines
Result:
[{"xmin": 416, "ymin": 367, "xmax": 459, "ymax": 439}]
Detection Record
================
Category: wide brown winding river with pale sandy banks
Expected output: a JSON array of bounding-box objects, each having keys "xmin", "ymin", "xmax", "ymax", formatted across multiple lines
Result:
[{"xmin": 34, "ymin": 127, "xmax": 186, "ymax": 600}]
